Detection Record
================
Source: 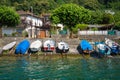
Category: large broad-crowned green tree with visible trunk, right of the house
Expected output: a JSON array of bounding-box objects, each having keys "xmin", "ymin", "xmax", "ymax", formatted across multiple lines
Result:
[{"xmin": 51, "ymin": 4, "xmax": 91, "ymax": 37}]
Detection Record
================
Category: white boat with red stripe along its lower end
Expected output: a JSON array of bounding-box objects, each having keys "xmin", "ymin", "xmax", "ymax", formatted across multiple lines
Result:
[{"xmin": 43, "ymin": 40, "xmax": 55, "ymax": 51}]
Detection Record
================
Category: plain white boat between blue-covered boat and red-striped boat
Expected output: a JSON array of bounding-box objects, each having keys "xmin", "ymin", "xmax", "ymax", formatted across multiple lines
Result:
[{"xmin": 30, "ymin": 40, "xmax": 42, "ymax": 52}]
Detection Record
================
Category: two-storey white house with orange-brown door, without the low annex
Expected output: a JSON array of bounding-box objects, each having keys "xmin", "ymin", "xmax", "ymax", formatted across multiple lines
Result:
[{"xmin": 17, "ymin": 11, "xmax": 50, "ymax": 38}]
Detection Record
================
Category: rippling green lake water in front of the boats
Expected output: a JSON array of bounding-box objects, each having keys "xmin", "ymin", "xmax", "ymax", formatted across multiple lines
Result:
[{"xmin": 0, "ymin": 56, "xmax": 120, "ymax": 80}]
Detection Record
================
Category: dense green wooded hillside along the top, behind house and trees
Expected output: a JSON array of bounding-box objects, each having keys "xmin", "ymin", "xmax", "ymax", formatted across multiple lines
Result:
[{"xmin": 0, "ymin": 0, "xmax": 120, "ymax": 15}]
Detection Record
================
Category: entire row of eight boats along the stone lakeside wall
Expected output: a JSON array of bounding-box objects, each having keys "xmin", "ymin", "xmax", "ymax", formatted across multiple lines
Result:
[{"xmin": 2, "ymin": 38, "xmax": 120, "ymax": 56}]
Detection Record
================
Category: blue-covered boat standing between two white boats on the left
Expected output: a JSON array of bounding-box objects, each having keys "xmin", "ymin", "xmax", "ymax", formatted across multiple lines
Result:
[{"xmin": 15, "ymin": 39, "xmax": 30, "ymax": 54}]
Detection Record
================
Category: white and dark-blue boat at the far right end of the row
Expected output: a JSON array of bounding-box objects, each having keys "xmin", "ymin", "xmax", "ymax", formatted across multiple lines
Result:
[{"xmin": 105, "ymin": 38, "xmax": 120, "ymax": 54}]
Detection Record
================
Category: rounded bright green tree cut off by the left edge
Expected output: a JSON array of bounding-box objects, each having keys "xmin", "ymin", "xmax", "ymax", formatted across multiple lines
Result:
[{"xmin": 0, "ymin": 6, "xmax": 20, "ymax": 37}]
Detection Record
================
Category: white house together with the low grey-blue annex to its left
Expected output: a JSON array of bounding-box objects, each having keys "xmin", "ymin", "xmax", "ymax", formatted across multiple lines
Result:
[{"xmin": 2, "ymin": 11, "xmax": 50, "ymax": 38}]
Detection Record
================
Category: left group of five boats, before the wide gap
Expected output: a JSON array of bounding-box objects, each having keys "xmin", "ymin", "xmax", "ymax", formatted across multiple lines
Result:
[{"xmin": 2, "ymin": 39, "xmax": 69, "ymax": 54}]
